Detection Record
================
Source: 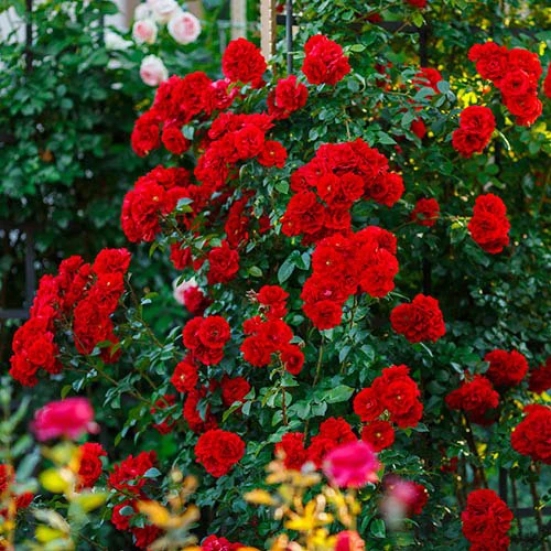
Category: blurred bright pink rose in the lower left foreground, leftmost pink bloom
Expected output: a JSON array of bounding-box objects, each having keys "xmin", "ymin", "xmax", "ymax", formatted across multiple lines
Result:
[{"xmin": 31, "ymin": 398, "xmax": 99, "ymax": 442}]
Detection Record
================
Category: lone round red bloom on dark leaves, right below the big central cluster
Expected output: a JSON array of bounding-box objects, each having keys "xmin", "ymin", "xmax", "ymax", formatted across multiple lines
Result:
[{"xmin": 390, "ymin": 294, "xmax": 446, "ymax": 343}]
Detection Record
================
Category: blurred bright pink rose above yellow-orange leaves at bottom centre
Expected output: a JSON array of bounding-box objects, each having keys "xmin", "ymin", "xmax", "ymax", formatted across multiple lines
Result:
[{"xmin": 323, "ymin": 440, "xmax": 381, "ymax": 488}]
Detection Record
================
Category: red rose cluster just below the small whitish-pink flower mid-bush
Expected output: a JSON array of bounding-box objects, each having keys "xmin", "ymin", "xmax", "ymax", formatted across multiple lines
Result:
[{"xmin": 182, "ymin": 316, "xmax": 231, "ymax": 365}]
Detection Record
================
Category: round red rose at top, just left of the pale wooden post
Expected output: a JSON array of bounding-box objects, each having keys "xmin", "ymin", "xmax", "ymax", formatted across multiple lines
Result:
[{"xmin": 222, "ymin": 38, "xmax": 267, "ymax": 87}]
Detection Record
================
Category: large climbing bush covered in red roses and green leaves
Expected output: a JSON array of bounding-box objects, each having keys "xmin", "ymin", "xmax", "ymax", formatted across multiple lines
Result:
[{"xmin": 3, "ymin": 0, "xmax": 551, "ymax": 549}]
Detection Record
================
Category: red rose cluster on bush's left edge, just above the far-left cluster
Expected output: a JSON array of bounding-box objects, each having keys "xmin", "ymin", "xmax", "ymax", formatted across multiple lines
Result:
[{"xmin": 121, "ymin": 166, "xmax": 191, "ymax": 243}]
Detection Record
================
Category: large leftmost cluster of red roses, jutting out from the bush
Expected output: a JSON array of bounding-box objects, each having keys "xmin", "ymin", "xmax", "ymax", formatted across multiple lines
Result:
[{"xmin": 10, "ymin": 249, "xmax": 130, "ymax": 386}]
